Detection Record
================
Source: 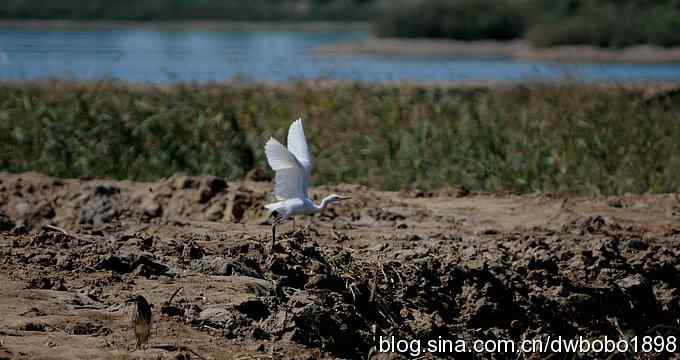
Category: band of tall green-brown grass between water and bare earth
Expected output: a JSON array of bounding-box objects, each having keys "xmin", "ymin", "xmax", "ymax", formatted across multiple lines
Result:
[{"xmin": 0, "ymin": 83, "xmax": 680, "ymax": 194}]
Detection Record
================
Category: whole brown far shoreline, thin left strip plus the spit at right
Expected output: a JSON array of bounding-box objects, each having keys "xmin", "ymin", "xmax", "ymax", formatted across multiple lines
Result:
[{"xmin": 0, "ymin": 19, "xmax": 680, "ymax": 64}]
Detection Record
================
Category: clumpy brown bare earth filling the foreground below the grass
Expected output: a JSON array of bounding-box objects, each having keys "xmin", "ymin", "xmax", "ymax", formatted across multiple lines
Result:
[{"xmin": 0, "ymin": 173, "xmax": 680, "ymax": 359}]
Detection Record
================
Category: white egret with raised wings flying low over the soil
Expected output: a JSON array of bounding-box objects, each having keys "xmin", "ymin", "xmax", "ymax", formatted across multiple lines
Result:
[{"xmin": 264, "ymin": 119, "xmax": 349, "ymax": 252}]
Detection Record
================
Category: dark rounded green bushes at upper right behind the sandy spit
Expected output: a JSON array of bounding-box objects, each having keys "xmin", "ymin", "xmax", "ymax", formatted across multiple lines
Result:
[{"xmin": 376, "ymin": 0, "xmax": 680, "ymax": 48}]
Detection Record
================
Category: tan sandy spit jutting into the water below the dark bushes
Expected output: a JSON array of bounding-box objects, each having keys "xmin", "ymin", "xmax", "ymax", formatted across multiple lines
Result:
[{"xmin": 315, "ymin": 38, "xmax": 680, "ymax": 63}]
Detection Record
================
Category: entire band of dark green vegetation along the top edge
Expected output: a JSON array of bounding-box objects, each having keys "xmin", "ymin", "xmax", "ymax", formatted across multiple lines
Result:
[{"xmin": 0, "ymin": 0, "xmax": 680, "ymax": 48}]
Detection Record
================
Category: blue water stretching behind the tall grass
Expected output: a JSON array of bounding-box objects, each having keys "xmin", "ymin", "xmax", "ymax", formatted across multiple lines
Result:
[{"xmin": 0, "ymin": 28, "xmax": 680, "ymax": 83}]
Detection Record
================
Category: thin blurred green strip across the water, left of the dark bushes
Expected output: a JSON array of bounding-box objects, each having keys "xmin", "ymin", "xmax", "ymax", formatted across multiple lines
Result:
[{"xmin": 0, "ymin": 0, "xmax": 377, "ymax": 21}]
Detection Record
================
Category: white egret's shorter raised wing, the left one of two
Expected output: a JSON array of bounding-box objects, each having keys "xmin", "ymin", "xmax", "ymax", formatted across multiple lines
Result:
[{"xmin": 264, "ymin": 138, "xmax": 307, "ymax": 200}]
